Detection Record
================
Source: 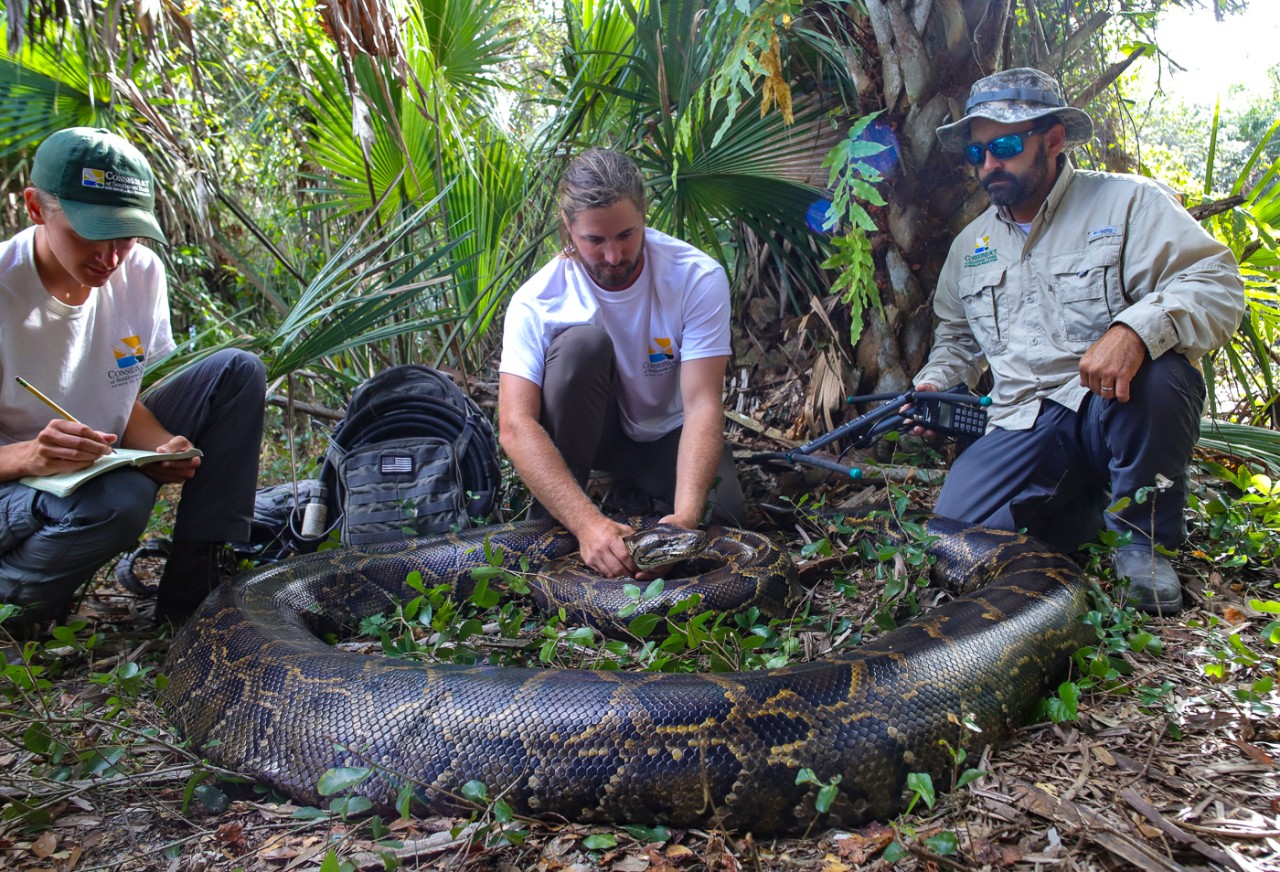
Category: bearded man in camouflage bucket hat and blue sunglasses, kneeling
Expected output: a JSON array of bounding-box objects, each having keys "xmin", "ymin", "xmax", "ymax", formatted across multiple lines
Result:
[{"xmin": 916, "ymin": 68, "xmax": 1244, "ymax": 615}]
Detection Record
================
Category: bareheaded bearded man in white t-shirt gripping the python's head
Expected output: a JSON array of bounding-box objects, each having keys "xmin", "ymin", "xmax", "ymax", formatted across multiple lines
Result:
[{"xmin": 498, "ymin": 149, "xmax": 745, "ymax": 576}]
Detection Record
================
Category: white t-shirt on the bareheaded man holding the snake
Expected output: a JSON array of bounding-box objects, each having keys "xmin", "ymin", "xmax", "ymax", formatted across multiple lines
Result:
[{"xmin": 498, "ymin": 228, "xmax": 731, "ymax": 442}]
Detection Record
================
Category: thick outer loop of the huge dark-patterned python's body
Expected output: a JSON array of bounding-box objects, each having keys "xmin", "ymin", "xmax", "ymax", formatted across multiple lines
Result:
[{"xmin": 165, "ymin": 519, "xmax": 1088, "ymax": 834}]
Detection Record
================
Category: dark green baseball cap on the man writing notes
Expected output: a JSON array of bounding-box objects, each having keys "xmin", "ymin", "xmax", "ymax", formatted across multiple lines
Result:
[{"xmin": 31, "ymin": 127, "xmax": 169, "ymax": 245}]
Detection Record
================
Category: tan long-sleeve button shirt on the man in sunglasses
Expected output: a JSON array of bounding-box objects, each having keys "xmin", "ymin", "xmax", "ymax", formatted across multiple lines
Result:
[{"xmin": 915, "ymin": 161, "xmax": 1244, "ymax": 430}]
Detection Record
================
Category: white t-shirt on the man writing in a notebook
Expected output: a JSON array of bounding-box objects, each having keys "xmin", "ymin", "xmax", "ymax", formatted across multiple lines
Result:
[{"xmin": 0, "ymin": 227, "xmax": 174, "ymax": 444}]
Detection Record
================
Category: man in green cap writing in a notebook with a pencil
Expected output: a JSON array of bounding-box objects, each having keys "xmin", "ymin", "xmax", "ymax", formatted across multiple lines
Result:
[{"xmin": 0, "ymin": 127, "xmax": 265, "ymax": 624}]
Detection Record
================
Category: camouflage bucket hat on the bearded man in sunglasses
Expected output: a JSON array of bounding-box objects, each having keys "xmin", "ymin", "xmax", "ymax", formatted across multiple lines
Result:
[{"xmin": 938, "ymin": 67, "xmax": 1093, "ymax": 151}]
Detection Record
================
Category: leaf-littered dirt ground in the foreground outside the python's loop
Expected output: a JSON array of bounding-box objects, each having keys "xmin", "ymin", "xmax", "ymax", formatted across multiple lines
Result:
[{"xmin": 0, "ymin": 453, "xmax": 1280, "ymax": 872}]
